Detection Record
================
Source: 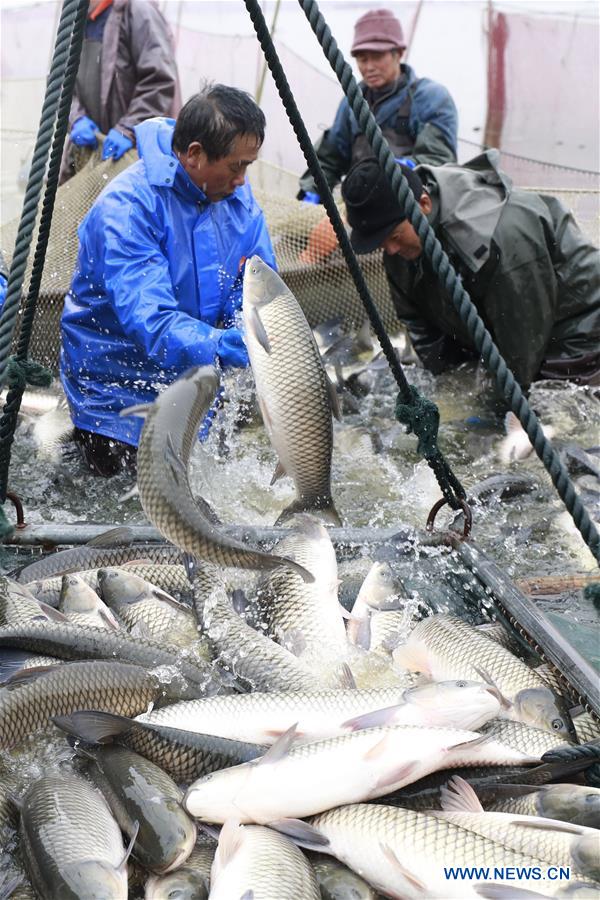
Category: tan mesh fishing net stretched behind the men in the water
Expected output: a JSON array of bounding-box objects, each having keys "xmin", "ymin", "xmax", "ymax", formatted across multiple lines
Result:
[{"xmin": 0, "ymin": 147, "xmax": 598, "ymax": 372}]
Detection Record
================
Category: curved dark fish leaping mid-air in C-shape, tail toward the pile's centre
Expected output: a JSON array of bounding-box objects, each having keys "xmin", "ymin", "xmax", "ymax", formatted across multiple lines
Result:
[{"xmin": 122, "ymin": 366, "xmax": 313, "ymax": 581}]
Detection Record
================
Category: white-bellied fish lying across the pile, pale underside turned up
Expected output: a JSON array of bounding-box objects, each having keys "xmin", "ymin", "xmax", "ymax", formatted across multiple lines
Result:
[{"xmin": 184, "ymin": 726, "xmax": 535, "ymax": 824}]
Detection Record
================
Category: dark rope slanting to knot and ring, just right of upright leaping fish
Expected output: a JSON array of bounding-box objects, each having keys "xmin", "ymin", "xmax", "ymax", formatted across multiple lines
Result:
[{"xmin": 245, "ymin": 0, "xmax": 466, "ymax": 509}]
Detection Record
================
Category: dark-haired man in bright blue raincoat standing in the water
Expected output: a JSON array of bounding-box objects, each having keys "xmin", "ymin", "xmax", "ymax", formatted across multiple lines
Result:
[{"xmin": 60, "ymin": 85, "xmax": 275, "ymax": 476}]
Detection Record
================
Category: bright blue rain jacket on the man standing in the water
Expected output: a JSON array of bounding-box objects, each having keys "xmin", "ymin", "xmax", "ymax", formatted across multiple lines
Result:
[{"xmin": 60, "ymin": 118, "xmax": 276, "ymax": 445}]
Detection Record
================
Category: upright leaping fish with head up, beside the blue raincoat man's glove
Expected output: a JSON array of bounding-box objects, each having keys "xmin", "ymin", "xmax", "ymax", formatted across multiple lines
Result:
[{"xmin": 243, "ymin": 256, "xmax": 341, "ymax": 525}]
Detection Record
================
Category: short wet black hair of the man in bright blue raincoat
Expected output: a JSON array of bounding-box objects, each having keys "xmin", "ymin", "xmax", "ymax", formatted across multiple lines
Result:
[{"xmin": 173, "ymin": 84, "xmax": 265, "ymax": 162}]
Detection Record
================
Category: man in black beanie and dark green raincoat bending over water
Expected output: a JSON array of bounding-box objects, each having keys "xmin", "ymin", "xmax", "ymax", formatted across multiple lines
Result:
[{"xmin": 342, "ymin": 150, "xmax": 600, "ymax": 389}]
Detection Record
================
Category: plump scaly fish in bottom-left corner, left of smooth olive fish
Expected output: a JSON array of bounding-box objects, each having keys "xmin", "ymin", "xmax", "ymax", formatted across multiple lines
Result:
[{"xmin": 21, "ymin": 773, "xmax": 127, "ymax": 900}]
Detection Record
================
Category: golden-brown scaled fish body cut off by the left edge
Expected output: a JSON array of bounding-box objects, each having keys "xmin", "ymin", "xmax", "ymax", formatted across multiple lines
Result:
[{"xmin": 0, "ymin": 661, "xmax": 160, "ymax": 749}]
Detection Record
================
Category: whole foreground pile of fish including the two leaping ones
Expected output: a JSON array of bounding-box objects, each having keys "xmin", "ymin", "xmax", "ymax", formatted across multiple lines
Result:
[{"xmin": 0, "ymin": 258, "xmax": 600, "ymax": 900}]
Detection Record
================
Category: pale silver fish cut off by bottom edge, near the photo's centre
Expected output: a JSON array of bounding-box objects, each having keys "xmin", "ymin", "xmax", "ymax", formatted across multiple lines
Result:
[{"xmin": 210, "ymin": 819, "xmax": 321, "ymax": 900}]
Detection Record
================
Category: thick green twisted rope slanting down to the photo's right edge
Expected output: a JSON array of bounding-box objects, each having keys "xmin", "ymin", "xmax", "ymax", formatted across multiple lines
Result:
[{"xmin": 298, "ymin": 0, "xmax": 600, "ymax": 562}]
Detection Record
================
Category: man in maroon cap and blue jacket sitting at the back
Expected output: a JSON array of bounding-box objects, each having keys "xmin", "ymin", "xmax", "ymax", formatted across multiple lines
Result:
[{"xmin": 298, "ymin": 9, "xmax": 458, "ymax": 202}]
